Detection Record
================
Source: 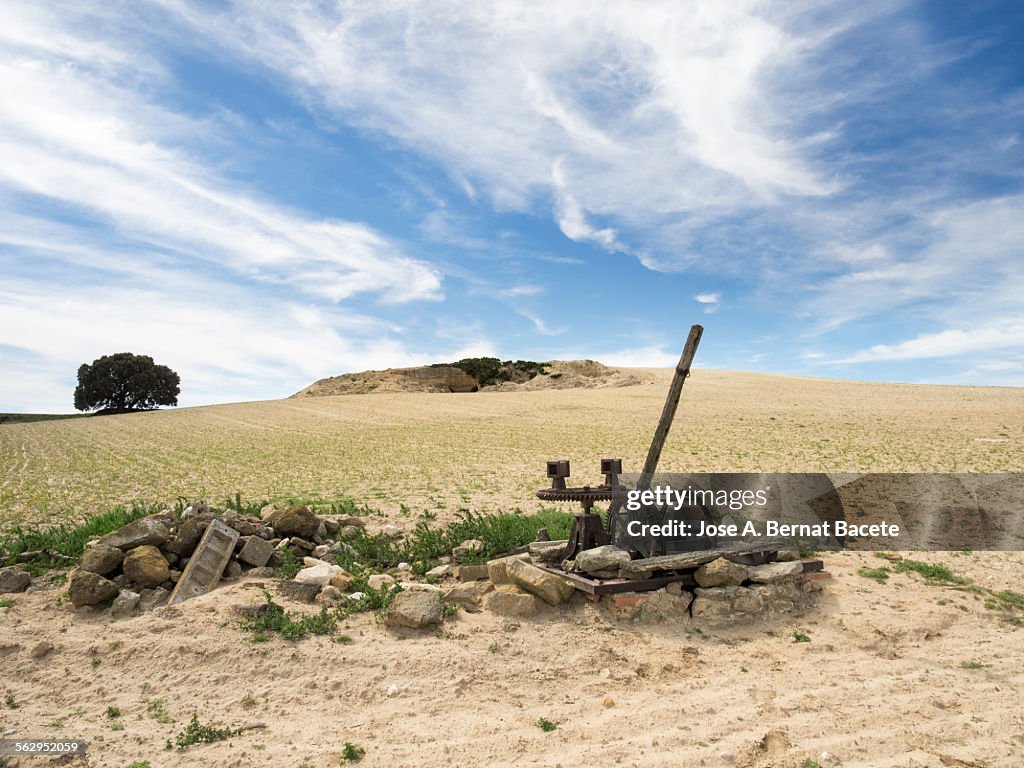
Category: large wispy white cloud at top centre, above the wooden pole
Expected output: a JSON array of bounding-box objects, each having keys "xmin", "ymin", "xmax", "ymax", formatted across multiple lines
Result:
[{"xmin": 153, "ymin": 0, "xmax": 836, "ymax": 268}]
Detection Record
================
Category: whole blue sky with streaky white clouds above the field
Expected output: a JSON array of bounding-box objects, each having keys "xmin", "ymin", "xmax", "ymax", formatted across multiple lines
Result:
[{"xmin": 0, "ymin": 0, "xmax": 1024, "ymax": 412}]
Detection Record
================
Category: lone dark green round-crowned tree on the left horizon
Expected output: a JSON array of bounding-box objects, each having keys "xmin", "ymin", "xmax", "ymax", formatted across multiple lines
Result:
[{"xmin": 75, "ymin": 352, "xmax": 181, "ymax": 414}]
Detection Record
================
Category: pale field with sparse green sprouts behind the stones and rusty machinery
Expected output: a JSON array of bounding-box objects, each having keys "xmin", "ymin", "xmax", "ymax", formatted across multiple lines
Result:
[{"xmin": 0, "ymin": 371, "xmax": 1024, "ymax": 526}]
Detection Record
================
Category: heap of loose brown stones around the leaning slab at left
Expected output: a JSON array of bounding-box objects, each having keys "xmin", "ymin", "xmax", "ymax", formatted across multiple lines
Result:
[{"xmin": 56, "ymin": 502, "xmax": 364, "ymax": 617}]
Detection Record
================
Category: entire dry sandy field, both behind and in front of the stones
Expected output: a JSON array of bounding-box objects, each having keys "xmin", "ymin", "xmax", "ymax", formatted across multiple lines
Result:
[{"xmin": 0, "ymin": 371, "xmax": 1024, "ymax": 768}]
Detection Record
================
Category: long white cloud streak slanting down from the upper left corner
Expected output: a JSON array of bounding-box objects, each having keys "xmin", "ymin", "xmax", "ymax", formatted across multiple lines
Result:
[{"xmin": 0, "ymin": 5, "xmax": 440, "ymax": 301}]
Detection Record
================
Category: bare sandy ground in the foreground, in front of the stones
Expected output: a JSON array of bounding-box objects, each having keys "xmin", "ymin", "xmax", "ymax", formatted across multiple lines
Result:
[{"xmin": 0, "ymin": 553, "xmax": 1024, "ymax": 768}]
